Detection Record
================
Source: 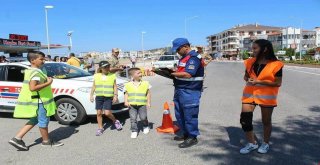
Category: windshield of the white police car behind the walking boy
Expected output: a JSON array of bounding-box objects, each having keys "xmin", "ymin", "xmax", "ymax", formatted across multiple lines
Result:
[{"xmin": 41, "ymin": 63, "xmax": 91, "ymax": 79}]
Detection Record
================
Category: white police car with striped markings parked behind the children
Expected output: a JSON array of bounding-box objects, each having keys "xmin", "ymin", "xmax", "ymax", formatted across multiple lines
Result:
[{"xmin": 0, "ymin": 62, "xmax": 128, "ymax": 124}]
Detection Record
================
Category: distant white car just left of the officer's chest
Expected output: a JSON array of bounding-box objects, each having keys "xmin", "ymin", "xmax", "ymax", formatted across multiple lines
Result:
[{"xmin": 153, "ymin": 55, "xmax": 179, "ymax": 69}]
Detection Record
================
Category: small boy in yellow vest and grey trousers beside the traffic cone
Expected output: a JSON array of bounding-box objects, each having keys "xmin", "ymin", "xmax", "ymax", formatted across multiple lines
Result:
[{"xmin": 124, "ymin": 68, "xmax": 151, "ymax": 138}]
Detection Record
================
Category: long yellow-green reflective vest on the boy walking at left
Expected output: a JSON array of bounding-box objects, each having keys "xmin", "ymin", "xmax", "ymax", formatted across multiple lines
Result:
[{"xmin": 14, "ymin": 69, "xmax": 56, "ymax": 118}]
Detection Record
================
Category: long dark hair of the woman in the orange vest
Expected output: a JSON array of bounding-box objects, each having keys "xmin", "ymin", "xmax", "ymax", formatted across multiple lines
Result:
[{"xmin": 250, "ymin": 39, "xmax": 278, "ymax": 72}]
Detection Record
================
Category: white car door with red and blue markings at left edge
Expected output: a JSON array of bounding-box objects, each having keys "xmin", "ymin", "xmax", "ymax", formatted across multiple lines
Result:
[{"xmin": 0, "ymin": 65, "xmax": 26, "ymax": 111}]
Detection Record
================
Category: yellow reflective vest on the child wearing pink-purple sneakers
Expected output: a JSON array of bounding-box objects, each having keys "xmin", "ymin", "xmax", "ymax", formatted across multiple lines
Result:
[{"xmin": 94, "ymin": 73, "xmax": 116, "ymax": 97}]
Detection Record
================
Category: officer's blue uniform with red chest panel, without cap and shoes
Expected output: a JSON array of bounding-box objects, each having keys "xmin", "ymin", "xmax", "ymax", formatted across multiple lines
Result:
[{"xmin": 173, "ymin": 51, "xmax": 204, "ymax": 137}]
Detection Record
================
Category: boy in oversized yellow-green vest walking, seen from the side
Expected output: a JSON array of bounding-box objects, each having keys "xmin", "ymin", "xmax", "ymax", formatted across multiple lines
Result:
[{"xmin": 9, "ymin": 51, "xmax": 63, "ymax": 151}]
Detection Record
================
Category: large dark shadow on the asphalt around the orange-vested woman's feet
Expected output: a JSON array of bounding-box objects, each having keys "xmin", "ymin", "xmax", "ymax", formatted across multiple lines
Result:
[{"xmin": 195, "ymin": 106, "xmax": 320, "ymax": 165}]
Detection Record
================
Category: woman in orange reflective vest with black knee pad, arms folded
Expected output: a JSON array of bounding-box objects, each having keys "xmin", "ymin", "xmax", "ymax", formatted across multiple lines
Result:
[{"xmin": 240, "ymin": 39, "xmax": 283, "ymax": 154}]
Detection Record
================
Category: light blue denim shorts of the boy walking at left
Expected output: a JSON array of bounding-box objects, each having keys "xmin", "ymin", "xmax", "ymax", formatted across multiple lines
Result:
[{"xmin": 27, "ymin": 104, "xmax": 50, "ymax": 128}]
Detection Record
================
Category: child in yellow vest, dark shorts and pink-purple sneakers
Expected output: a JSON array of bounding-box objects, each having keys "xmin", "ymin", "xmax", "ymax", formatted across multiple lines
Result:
[{"xmin": 90, "ymin": 61, "xmax": 122, "ymax": 136}]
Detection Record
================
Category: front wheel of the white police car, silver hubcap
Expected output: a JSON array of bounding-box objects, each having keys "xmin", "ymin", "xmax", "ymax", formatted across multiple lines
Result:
[{"xmin": 54, "ymin": 98, "xmax": 87, "ymax": 125}]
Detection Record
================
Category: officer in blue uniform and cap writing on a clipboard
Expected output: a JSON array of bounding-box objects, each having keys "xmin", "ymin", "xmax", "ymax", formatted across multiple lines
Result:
[{"xmin": 172, "ymin": 38, "xmax": 204, "ymax": 148}]
